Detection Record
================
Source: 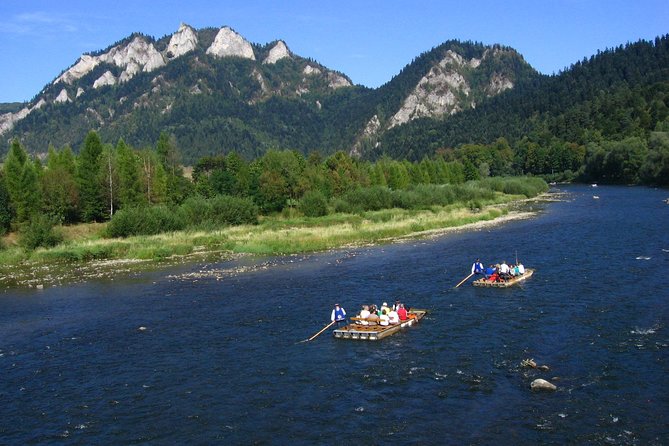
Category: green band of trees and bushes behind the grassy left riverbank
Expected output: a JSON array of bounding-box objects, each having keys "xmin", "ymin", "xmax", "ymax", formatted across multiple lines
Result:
[{"xmin": 0, "ymin": 131, "xmax": 495, "ymax": 245}]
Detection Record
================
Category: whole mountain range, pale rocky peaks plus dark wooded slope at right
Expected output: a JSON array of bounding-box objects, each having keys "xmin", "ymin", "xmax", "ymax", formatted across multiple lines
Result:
[{"xmin": 0, "ymin": 24, "xmax": 669, "ymax": 173}]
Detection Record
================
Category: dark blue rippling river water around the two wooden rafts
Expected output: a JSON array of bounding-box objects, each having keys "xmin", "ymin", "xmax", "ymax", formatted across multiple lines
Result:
[{"xmin": 0, "ymin": 186, "xmax": 669, "ymax": 445}]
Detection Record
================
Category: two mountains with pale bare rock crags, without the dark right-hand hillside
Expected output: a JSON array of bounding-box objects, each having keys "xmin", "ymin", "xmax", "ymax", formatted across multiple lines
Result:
[{"xmin": 0, "ymin": 24, "xmax": 539, "ymax": 161}]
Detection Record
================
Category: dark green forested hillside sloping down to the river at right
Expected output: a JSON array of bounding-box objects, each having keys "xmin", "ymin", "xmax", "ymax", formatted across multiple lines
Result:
[{"xmin": 374, "ymin": 36, "xmax": 669, "ymax": 185}]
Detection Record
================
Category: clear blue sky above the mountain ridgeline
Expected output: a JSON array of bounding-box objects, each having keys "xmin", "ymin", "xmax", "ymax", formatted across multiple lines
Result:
[{"xmin": 0, "ymin": 0, "xmax": 669, "ymax": 102}]
